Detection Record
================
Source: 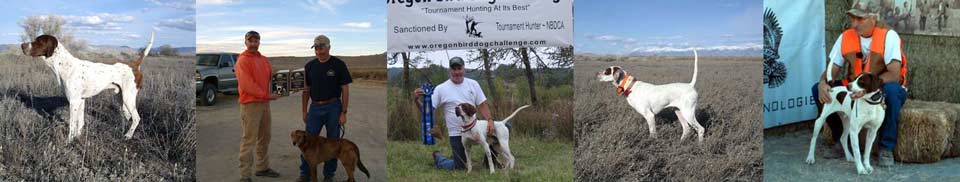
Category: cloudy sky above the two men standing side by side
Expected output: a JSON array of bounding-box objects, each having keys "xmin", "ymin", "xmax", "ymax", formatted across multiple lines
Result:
[{"xmin": 197, "ymin": 0, "xmax": 387, "ymax": 56}]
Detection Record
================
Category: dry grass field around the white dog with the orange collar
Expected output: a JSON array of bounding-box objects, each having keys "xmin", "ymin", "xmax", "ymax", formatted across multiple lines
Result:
[{"xmin": 574, "ymin": 56, "xmax": 763, "ymax": 181}]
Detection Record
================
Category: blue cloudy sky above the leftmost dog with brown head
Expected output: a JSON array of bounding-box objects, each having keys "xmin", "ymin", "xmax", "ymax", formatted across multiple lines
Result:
[{"xmin": 0, "ymin": 0, "xmax": 196, "ymax": 47}]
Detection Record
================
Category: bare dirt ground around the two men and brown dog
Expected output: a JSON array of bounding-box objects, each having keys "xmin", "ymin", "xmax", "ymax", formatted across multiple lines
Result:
[{"xmin": 197, "ymin": 82, "xmax": 387, "ymax": 181}]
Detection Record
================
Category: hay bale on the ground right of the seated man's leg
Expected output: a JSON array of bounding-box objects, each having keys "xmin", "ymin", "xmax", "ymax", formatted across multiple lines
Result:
[{"xmin": 894, "ymin": 100, "xmax": 956, "ymax": 163}]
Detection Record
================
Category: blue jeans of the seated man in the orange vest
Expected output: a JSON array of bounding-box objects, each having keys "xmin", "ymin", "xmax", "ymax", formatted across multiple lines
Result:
[{"xmin": 812, "ymin": 82, "xmax": 907, "ymax": 150}]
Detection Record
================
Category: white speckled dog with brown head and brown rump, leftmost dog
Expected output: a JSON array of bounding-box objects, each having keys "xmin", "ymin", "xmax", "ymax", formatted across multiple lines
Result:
[{"xmin": 20, "ymin": 33, "xmax": 153, "ymax": 142}]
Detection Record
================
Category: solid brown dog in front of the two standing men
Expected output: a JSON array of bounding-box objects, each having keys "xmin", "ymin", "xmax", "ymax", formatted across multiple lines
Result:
[{"xmin": 290, "ymin": 130, "xmax": 370, "ymax": 182}]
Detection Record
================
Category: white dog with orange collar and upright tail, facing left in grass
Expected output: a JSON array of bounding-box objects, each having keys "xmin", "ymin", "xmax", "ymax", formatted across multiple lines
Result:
[{"xmin": 597, "ymin": 50, "xmax": 704, "ymax": 142}]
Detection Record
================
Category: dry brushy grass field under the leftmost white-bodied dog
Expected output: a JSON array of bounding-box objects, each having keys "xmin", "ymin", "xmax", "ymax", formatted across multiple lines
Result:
[{"xmin": 0, "ymin": 55, "xmax": 197, "ymax": 181}]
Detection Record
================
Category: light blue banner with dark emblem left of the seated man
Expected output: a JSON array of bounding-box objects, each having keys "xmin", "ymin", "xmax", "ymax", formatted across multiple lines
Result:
[{"xmin": 763, "ymin": 0, "xmax": 826, "ymax": 128}]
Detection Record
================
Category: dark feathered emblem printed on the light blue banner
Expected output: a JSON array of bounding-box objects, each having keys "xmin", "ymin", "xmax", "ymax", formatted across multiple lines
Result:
[{"xmin": 763, "ymin": 8, "xmax": 787, "ymax": 88}]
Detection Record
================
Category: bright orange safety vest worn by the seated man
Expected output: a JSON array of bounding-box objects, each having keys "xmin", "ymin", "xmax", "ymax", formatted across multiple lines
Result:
[{"xmin": 840, "ymin": 27, "xmax": 907, "ymax": 87}]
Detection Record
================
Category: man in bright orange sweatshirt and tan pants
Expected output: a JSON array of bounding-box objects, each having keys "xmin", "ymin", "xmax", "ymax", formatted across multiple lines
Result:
[{"xmin": 235, "ymin": 31, "xmax": 280, "ymax": 181}]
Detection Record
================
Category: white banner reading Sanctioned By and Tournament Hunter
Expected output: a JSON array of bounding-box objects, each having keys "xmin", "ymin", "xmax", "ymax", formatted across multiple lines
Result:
[{"xmin": 387, "ymin": 0, "xmax": 573, "ymax": 52}]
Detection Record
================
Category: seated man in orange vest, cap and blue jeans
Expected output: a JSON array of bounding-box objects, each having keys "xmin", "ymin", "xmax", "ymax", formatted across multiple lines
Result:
[{"xmin": 812, "ymin": 3, "xmax": 907, "ymax": 167}]
